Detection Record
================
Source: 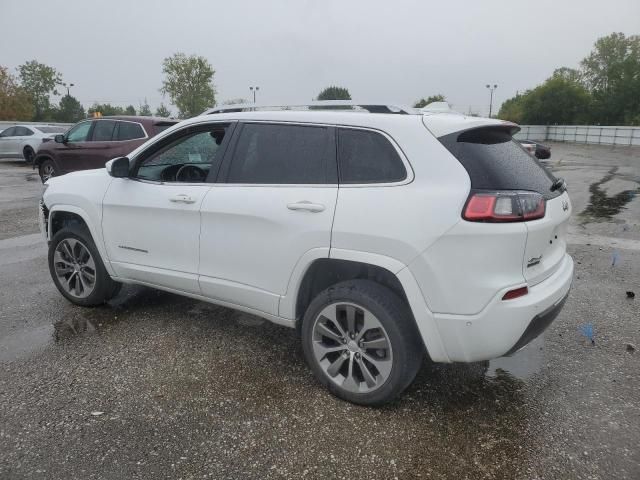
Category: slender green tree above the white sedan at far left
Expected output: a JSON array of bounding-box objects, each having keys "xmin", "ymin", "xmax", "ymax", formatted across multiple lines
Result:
[{"xmin": 18, "ymin": 60, "xmax": 62, "ymax": 121}]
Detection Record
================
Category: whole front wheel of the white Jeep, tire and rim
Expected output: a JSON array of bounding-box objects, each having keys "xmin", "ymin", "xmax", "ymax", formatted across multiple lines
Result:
[{"xmin": 48, "ymin": 225, "xmax": 122, "ymax": 307}]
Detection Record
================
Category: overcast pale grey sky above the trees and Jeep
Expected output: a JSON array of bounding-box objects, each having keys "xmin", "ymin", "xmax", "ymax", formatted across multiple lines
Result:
[{"xmin": 0, "ymin": 0, "xmax": 640, "ymax": 113}]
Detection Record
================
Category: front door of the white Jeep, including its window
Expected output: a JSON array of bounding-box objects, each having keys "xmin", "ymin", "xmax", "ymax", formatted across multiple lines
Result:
[{"xmin": 102, "ymin": 124, "xmax": 235, "ymax": 294}]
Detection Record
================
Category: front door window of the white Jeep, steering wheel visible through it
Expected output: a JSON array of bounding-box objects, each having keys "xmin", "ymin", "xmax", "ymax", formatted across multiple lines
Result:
[{"xmin": 135, "ymin": 124, "xmax": 228, "ymax": 183}]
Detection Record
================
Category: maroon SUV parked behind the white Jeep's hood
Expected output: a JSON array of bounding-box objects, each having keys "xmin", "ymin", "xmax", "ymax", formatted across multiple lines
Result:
[{"xmin": 33, "ymin": 116, "xmax": 178, "ymax": 183}]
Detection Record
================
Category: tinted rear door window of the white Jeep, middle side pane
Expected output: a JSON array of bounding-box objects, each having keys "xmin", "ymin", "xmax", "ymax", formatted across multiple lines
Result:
[{"xmin": 227, "ymin": 123, "xmax": 335, "ymax": 184}]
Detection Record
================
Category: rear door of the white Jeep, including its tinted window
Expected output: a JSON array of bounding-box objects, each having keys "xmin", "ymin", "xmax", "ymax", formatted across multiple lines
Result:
[{"xmin": 199, "ymin": 123, "xmax": 338, "ymax": 315}]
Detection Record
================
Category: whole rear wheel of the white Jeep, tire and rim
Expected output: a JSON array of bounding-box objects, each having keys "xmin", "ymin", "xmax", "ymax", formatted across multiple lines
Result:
[{"xmin": 301, "ymin": 280, "xmax": 424, "ymax": 406}]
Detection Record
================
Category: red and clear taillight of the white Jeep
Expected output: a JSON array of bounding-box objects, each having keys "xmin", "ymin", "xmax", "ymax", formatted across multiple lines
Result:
[{"xmin": 462, "ymin": 191, "xmax": 546, "ymax": 222}]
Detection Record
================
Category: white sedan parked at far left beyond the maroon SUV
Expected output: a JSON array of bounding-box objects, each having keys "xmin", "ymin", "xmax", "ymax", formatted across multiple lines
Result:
[{"xmin": 0, "ymin": 125, "xmax": 68, "ymax": 163}]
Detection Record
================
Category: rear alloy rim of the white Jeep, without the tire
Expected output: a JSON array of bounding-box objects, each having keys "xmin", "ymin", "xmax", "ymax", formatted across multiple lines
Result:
[{"xmin": 312, "ymin": 302, "xmax": 393, "ymax": 393}]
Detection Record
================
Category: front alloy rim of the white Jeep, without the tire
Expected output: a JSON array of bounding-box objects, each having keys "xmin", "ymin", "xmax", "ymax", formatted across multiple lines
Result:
[{"xmin": 53, "ymin": 238, "xmax": 96, "ymax": 298}]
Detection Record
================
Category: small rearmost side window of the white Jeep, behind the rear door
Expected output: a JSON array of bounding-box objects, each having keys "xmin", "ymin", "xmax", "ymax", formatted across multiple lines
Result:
[{"xmin": 338, "ymin": 129, "xmax": 407, "ymax": 183}]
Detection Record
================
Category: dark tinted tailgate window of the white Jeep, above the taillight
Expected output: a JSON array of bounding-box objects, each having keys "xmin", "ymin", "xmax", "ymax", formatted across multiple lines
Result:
[{"xmin": 439, "ymin": 128, "xmax": 562, "ymax": 198}]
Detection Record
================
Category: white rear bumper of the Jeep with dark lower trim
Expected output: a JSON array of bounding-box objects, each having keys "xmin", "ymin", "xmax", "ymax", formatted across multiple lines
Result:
[{"xmin": 435, "ymin": 254, "xmax": 573, "ymax": 362}]
